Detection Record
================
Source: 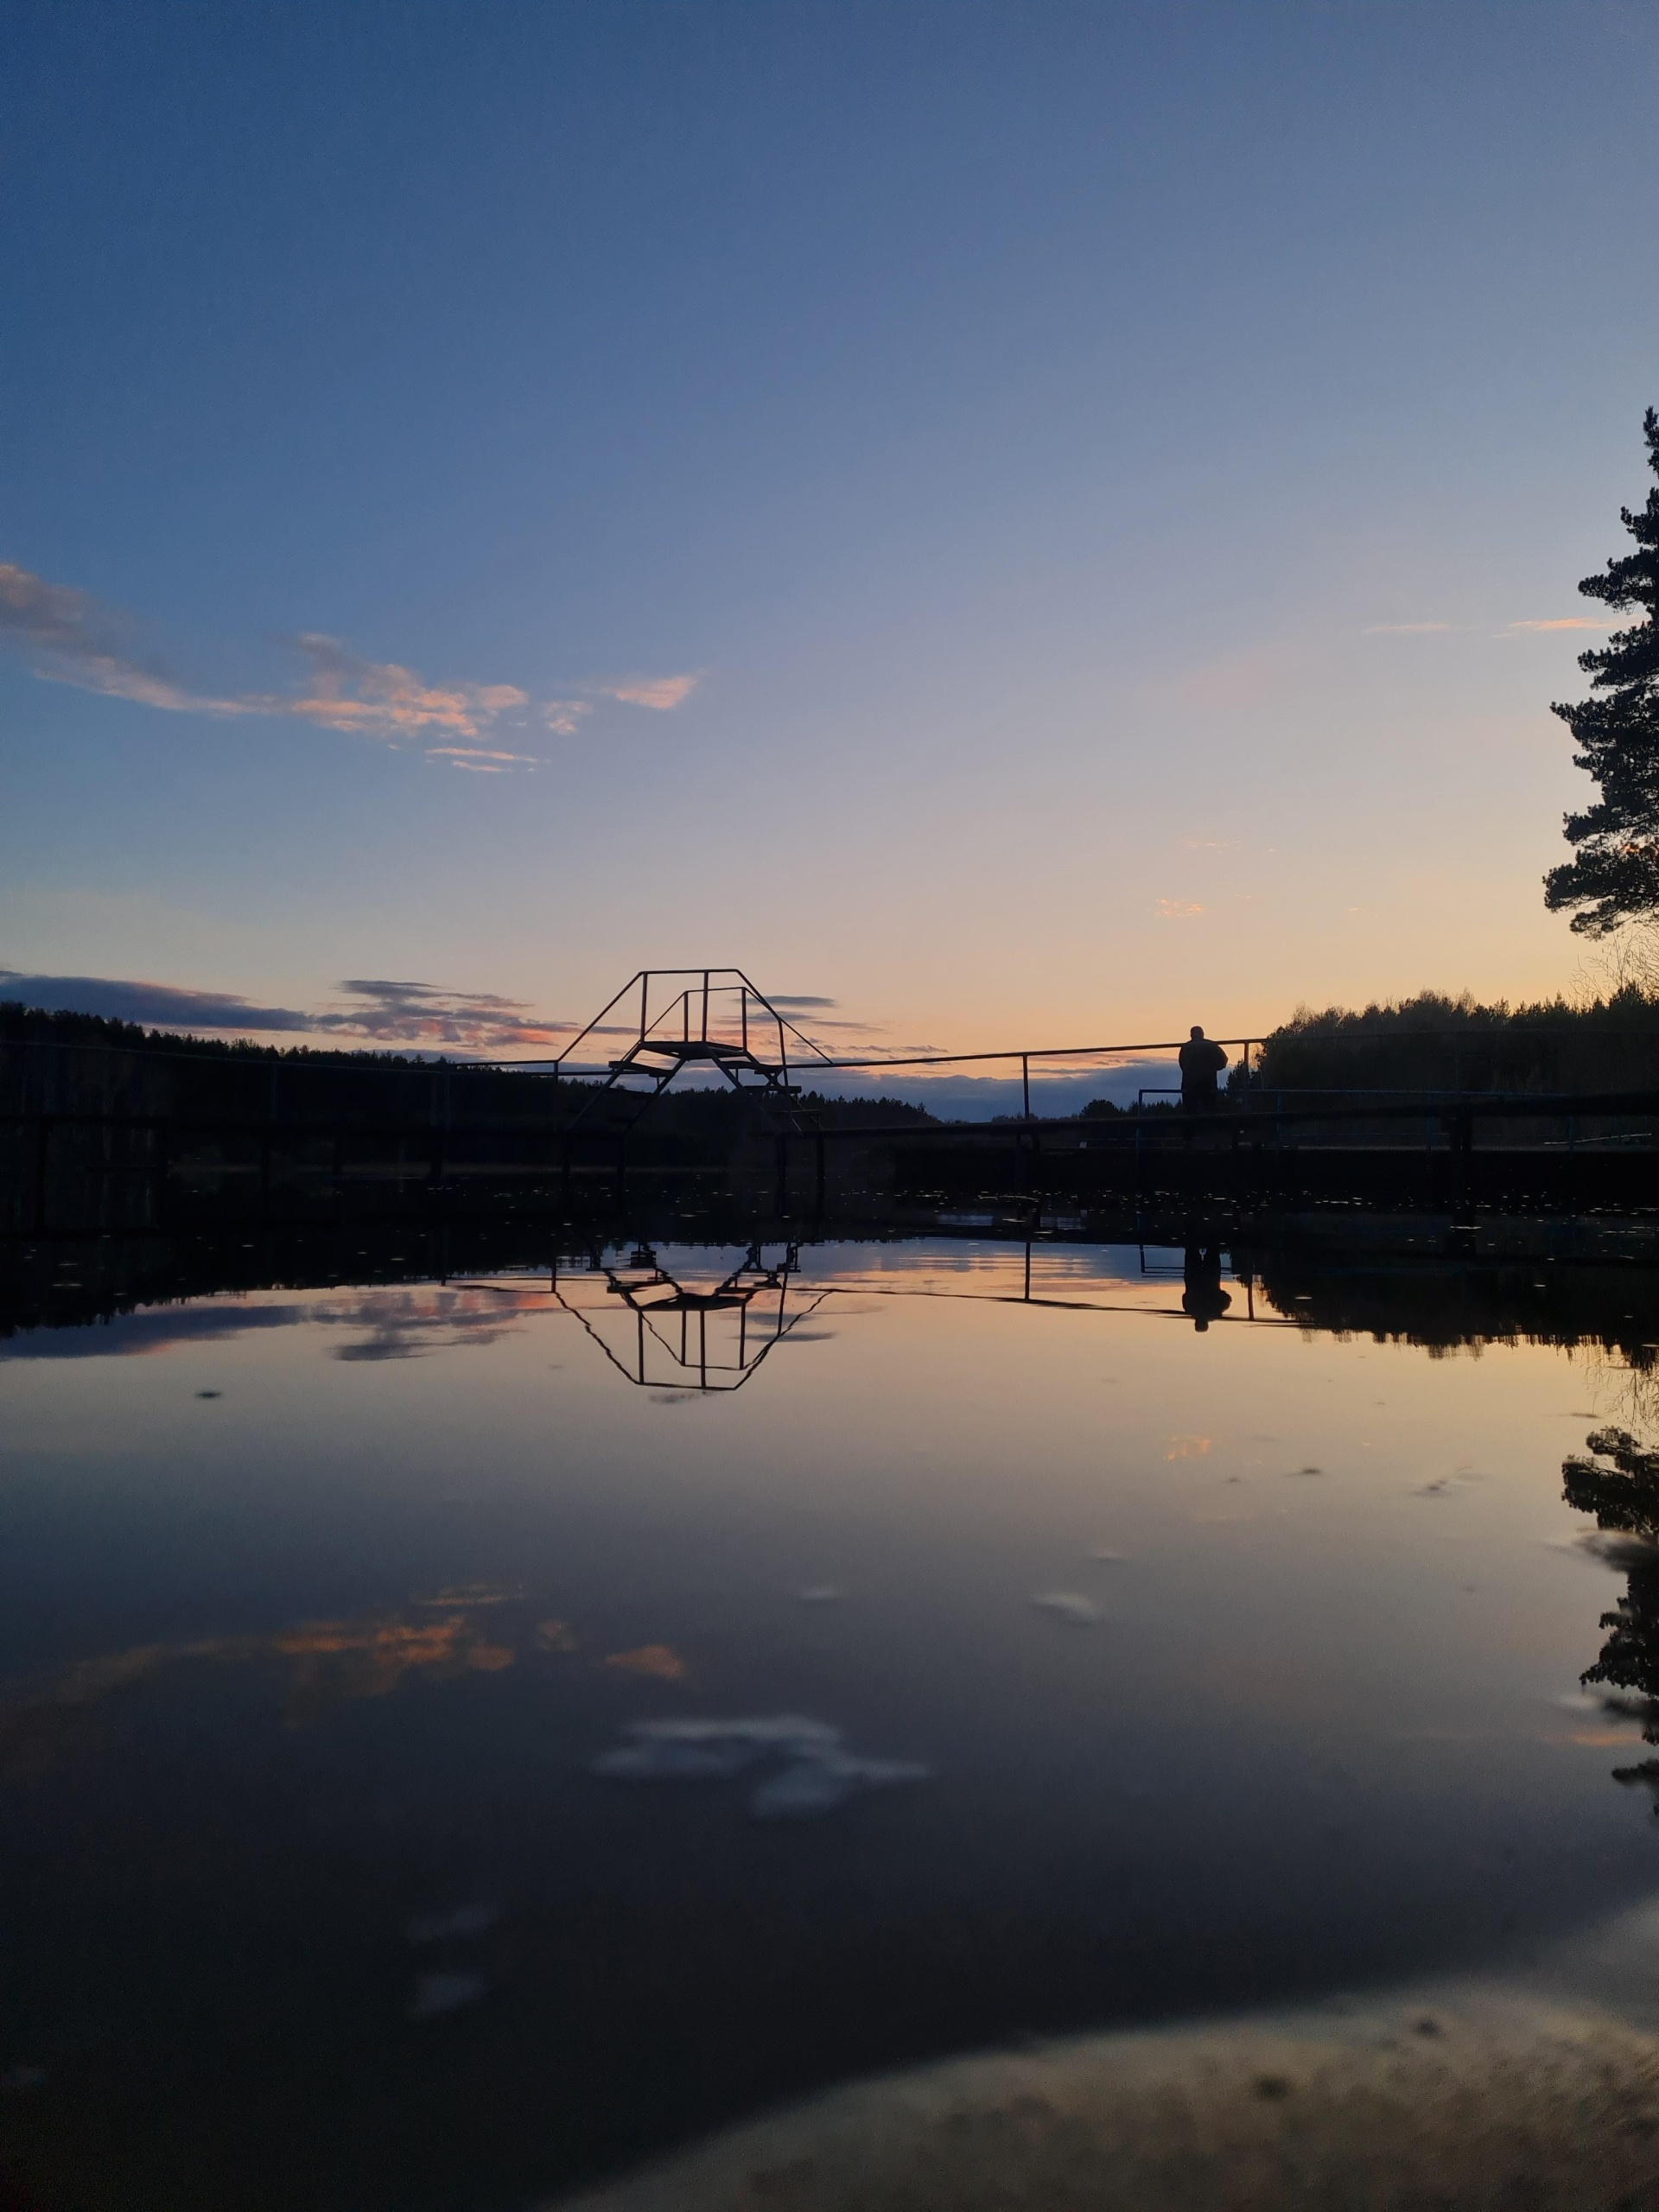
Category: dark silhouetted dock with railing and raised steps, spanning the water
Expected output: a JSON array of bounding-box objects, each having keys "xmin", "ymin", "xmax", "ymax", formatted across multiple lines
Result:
[{"xmin": 0, "ymin": 969, "xmax": 1659, "ymax": 1239}]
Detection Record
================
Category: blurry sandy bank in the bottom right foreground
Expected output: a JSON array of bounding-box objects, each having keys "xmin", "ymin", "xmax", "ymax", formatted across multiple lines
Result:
[{"xmin": 564, "ymin": 1913, "xmax": 1659, "ymax": 2212}]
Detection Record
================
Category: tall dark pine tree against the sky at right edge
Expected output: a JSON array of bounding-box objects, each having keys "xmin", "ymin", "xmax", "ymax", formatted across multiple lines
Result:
[{"xmin": 1544, "ymin": 407, "xmax": 1659, "ymax": 938}]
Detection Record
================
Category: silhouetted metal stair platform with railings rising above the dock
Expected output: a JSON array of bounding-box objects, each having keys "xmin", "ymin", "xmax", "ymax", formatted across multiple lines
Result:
[{"xmin": 553, "ymin": 969, "xmax": 844, "ymax": 1126}]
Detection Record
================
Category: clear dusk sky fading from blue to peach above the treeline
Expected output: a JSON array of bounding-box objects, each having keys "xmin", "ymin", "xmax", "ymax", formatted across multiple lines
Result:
[{"xmin": 0, "ymin": 0, "xmax": 1659, "ymax": 1088}]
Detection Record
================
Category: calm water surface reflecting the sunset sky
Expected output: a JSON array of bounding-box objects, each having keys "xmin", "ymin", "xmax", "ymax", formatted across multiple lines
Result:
[{"xmin": 0, "ymin": 1241, "xmax": 1659, "ymax": 2212}]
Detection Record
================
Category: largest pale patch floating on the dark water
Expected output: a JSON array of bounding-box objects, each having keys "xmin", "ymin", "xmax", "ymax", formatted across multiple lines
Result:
[{"xmin": 588, "ymin": 1712, "xmax": 931, "ymax": 1821}]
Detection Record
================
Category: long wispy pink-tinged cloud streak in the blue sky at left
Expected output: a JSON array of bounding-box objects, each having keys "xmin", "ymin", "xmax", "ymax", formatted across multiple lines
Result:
[{"xmin": 0, "ymin": 562, "xmax": 699, "ymax": 774}]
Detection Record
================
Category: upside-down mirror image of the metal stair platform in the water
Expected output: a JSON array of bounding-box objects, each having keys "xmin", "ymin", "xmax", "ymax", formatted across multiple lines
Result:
[{"xmin": 553, "ymin": 1243, "xmax": 830, "ymax": 1391}]
